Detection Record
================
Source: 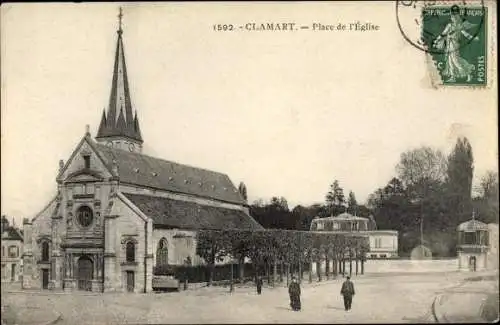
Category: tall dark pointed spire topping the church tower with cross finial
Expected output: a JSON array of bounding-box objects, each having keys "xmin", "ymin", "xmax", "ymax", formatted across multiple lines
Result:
[{"xmin": 96, "ymin": 8, "xmax": 143, "ymax": 143}]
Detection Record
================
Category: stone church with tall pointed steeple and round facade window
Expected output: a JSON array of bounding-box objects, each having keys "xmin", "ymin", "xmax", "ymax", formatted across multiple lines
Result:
[{"xmin": 22, "ymin": 9, "xmax": 262, "ymax": 292}]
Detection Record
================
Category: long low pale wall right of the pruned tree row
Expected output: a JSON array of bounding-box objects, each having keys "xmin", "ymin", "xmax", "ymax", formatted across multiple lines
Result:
[{"xmin": 365, "ymin": 258, "xmax": 458, "ymax": 274}]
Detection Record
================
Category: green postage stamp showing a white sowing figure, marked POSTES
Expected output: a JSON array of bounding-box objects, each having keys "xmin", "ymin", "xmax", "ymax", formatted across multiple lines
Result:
[{"xmin": 422, "ymin": 5, "xmax": 488, "ymax": 86}]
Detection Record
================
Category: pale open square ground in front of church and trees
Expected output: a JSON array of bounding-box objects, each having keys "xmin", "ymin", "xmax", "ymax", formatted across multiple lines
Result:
[{"xmin": 2, "ymin": 272, "xmax": 496, "ymax": 325}]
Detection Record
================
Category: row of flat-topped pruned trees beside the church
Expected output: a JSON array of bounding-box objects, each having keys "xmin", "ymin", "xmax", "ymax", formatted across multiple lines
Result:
[{"xmin": 197, "ymin": 229, "xmax": 369, "ymax": 290}]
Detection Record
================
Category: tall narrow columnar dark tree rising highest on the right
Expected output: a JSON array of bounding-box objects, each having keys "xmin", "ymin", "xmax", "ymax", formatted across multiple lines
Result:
[{"xmin": 446, "ymin": 138, "xmax": 474, "ymax": 225}]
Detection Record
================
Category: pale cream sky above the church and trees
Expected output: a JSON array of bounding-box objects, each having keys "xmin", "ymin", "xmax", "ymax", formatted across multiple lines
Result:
[{"xmin": 1, "ymin": 2, "xmax": 498, "ymax": 222}]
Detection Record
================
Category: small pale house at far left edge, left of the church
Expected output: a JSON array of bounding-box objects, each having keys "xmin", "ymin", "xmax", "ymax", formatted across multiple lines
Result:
[{"xmin": 1, "ymin": 216, "xmax": 23, "ymax": 282}]
